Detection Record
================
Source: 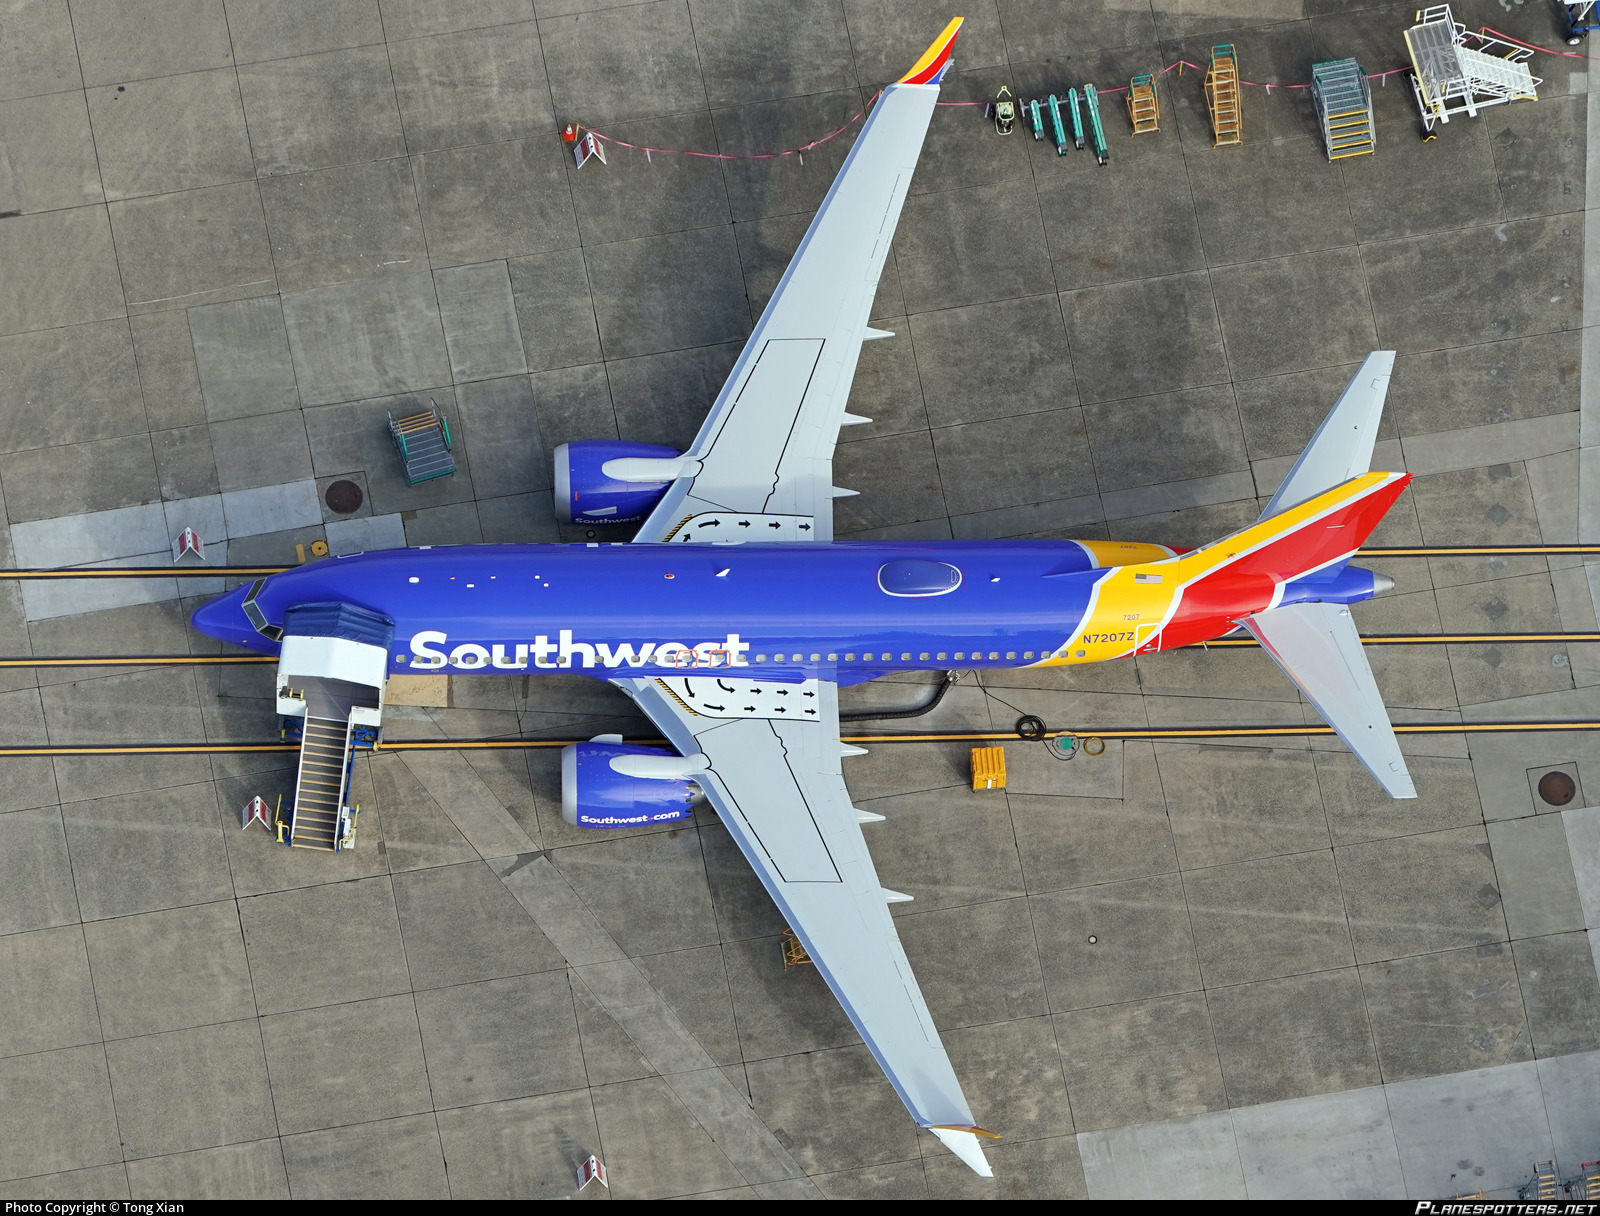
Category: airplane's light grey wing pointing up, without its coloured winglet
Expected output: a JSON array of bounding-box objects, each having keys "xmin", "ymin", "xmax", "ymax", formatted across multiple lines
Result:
[{"xmin": 634, "ymin": 85, "xmax": 939, "ymax": 541}]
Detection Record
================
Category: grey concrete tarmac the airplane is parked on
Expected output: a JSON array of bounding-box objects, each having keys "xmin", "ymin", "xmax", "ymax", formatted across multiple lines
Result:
[{"xmin": 0, "ymin": 0, "xmax": 1600, "ymax": 1198}]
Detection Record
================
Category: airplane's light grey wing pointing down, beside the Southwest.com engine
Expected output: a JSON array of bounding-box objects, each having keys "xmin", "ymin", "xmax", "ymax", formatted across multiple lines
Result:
[{"xmin": 613, "ymin": 677, "xmax": 989, "ymax": 1178}]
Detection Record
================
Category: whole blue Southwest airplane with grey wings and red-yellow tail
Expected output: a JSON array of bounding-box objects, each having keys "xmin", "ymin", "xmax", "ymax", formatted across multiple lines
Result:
[{"xmin": 194, "ymin": 19, "xmax": 1414, "ymax": 1176}]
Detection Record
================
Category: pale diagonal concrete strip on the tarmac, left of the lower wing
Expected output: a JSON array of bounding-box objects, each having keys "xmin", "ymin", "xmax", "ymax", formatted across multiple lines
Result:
[{"xmin": 493, "ymin": 856, "xmax": 822, "ymax": 1198}]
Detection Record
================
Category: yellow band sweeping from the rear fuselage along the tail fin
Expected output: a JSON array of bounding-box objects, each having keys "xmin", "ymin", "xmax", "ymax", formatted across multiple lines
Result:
[{"xmin": 1029, "ymin": 472, "xmax": 1394, "ymax": 667}]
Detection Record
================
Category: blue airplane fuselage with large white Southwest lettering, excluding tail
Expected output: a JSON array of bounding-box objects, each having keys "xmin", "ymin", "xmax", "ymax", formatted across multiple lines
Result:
[{"xmin": 194, "ymin": 541, "xmax": 1104, "ymax": 683}]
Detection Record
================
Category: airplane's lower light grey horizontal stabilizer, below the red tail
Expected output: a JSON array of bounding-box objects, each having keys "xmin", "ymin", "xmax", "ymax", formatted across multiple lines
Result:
[{"xmin": 1240, "ymin": 603, "xmax": 1416, "ymax": 798}]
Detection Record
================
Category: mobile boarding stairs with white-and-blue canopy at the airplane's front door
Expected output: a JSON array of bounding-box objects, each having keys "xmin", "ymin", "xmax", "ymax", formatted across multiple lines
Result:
[{"xmin": 277, "ymin": 603, "xmax": 394, "ymax": 853}]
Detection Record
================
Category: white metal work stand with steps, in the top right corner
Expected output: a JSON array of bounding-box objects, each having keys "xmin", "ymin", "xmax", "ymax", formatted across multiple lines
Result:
[{"xmin": 1405, "ymin": 5, "xmax": 1544, "ymax": 134}]
